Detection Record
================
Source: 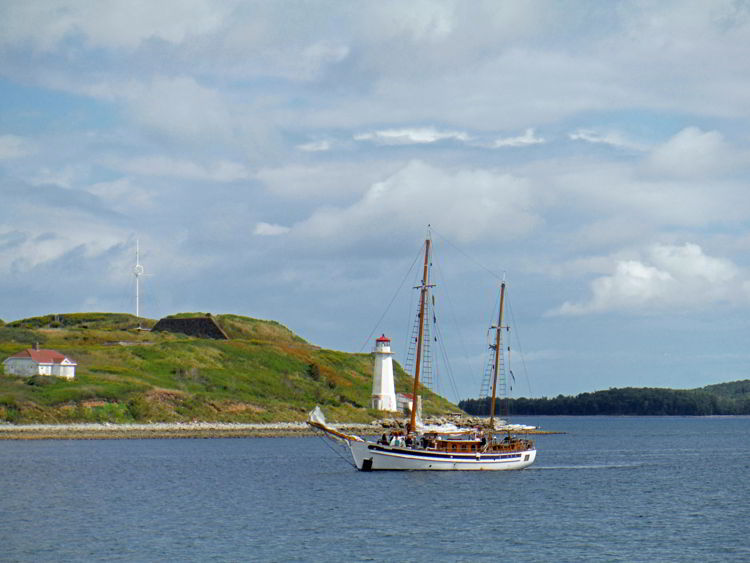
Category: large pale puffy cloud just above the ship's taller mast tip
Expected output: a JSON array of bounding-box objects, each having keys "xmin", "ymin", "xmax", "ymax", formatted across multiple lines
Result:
[{"xmin": 292, "ymin": 161, "xmax": 539, "ymax": 246}]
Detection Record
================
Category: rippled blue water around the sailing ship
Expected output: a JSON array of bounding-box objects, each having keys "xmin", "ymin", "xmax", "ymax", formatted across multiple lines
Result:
[{"xmin": 0, "ymin": 417, "xmax": 750, "ymax": 561}]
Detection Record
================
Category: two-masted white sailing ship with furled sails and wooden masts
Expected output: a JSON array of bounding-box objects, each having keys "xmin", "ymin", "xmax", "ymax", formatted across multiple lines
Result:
[{"xmin": 308, "ymin": 236, "xmax": 536, "ymax": 471}]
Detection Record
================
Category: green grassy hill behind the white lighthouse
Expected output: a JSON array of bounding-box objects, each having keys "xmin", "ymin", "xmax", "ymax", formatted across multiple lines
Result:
[{"xmin": 0, "ymin": 313, "xmax": 458, "ymax": 422}]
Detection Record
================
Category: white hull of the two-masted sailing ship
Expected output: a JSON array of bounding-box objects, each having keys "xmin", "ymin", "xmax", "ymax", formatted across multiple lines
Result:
[{"xmin": 348, "ymin": 441, "xmax": 536, "ymax": 471}]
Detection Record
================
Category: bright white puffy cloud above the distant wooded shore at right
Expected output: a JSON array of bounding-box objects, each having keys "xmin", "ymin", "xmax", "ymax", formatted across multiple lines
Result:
[{"xmin": 551, "ymin": 243, "xmax": 750, "ymax": 315}]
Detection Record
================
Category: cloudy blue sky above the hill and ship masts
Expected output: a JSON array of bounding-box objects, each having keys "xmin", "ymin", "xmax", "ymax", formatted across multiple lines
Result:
[{"xmin": 0, "ymin": 0, "xmax": 750, "ymax": 400}]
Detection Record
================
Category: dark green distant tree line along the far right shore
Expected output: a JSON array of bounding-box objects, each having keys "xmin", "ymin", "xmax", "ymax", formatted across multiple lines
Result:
[{"xmin": 458, "ymin": 382, "xmax": 750, "ymax": 416}]
